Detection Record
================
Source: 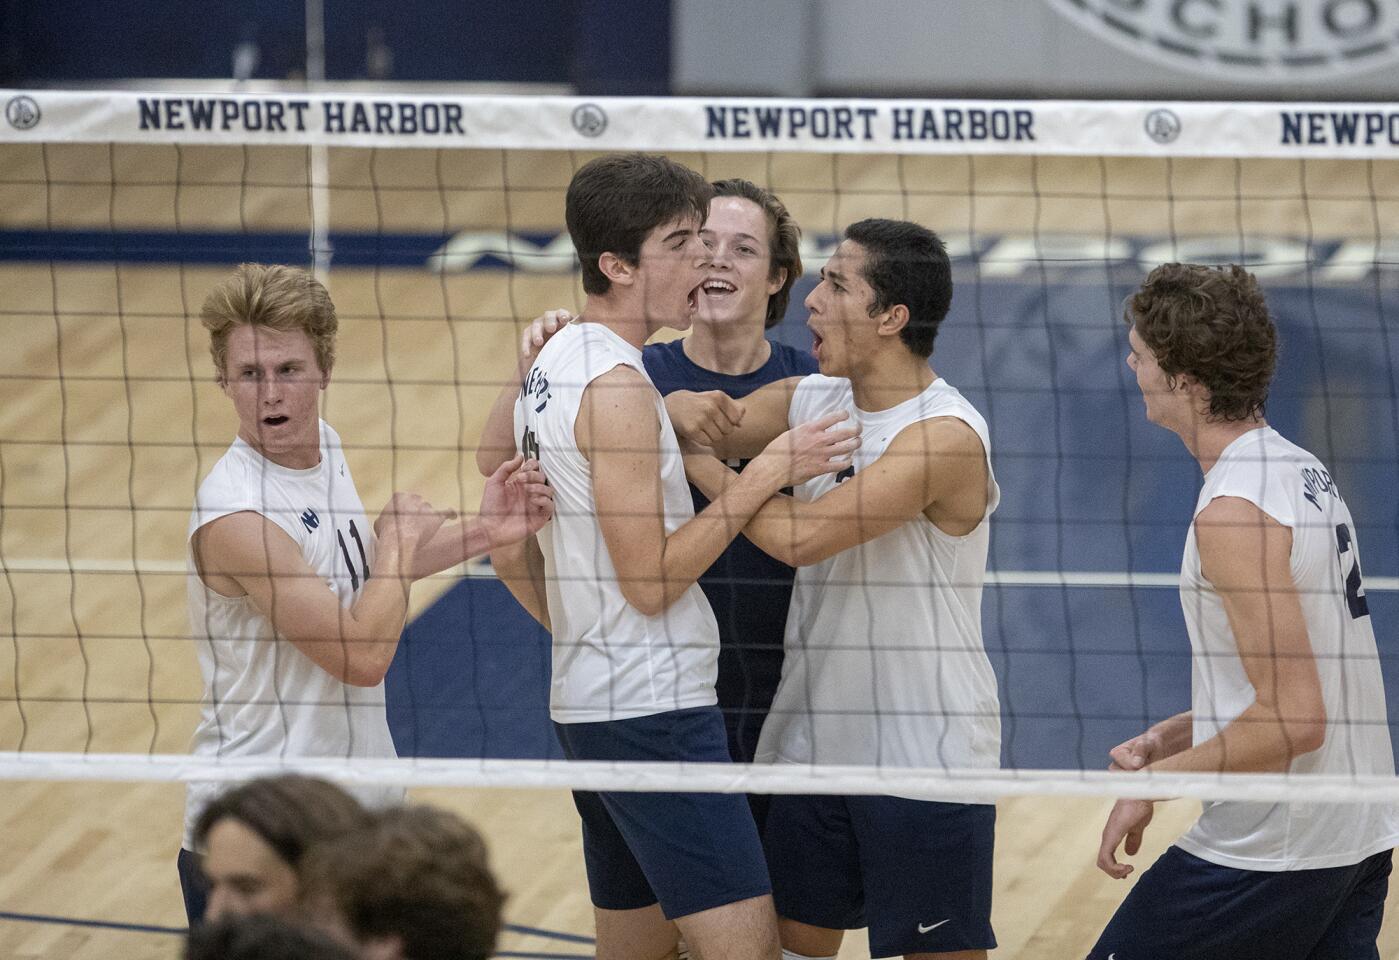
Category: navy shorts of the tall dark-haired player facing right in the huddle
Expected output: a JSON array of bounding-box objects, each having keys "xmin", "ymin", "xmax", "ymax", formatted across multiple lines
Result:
[{"xmin": 554, "ymin": 707, "xmax": 772, "ymax": 919}]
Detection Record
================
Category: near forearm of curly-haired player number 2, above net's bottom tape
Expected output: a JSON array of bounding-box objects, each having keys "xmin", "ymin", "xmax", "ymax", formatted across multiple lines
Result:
[{"xmin": 1149, "ymin": 701, "xmax": 1326, "ymax": 772}]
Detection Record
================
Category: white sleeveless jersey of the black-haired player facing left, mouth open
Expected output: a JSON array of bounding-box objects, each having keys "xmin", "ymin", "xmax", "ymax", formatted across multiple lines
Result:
[{"xmin": 758, "ymin": 375, "xmax": 1000, "ymax": 783}]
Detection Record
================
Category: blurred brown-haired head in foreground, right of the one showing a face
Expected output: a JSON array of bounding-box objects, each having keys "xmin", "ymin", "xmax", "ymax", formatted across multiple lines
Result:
[{"xmin": 302, "ymin": 805, "xmax": 505, "ymax": 960}]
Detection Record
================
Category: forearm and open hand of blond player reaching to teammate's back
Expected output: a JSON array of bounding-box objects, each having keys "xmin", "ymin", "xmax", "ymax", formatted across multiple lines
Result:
[{"xmin": 413, "ymin": 453, "xmax": 554, "ymax": 579}]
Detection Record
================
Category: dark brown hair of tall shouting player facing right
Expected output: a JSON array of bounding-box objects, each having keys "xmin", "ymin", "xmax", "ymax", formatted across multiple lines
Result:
[{"xmin": 564, "ymin": 154, "xmax": 713, "ymax": 294}]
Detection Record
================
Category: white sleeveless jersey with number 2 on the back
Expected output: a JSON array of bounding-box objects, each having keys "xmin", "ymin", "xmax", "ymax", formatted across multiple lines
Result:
[{"xmin": 1178, "ymin": 427, "xmax": 1399, "ymax": 870}]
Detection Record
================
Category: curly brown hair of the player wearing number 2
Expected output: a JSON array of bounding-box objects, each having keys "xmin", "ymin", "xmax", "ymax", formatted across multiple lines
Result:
[{"xmin": 1122, "ymin": 263, "xmax": 1277, "ymax": 421}]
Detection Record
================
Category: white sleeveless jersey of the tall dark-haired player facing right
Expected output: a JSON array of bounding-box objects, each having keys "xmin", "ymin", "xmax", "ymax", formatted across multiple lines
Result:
[{"xmin": 515, "ymin": 322, "xmax": 719, "ymax": 723}]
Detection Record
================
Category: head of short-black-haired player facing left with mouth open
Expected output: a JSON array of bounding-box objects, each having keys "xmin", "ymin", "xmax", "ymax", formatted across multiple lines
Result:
[{"xmin": 806, "ymin": 220, "xmax": 953, "ymax": 378}]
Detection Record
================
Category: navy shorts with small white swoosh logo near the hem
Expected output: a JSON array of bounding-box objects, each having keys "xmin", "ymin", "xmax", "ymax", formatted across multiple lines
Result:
[{"xmin": 762, "ymin": 796, "xmax": 996, "ymax": 957}]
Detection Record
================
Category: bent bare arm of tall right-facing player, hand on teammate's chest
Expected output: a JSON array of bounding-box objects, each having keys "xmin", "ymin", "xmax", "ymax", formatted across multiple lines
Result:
[{"xmin": 574, "ymin": 367, "xmax": 858, "ymax": 616}]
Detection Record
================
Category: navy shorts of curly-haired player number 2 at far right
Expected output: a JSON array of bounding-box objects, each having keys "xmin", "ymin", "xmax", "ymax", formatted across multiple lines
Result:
[{"xmin": 1088, "ymin": 847, "xmax": 1392, "ymax": 960}]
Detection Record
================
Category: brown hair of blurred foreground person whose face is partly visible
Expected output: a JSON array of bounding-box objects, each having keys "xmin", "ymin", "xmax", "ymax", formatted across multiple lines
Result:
[{"xmin": 194, "ymin": 774, "xmax": 369, "ymax": 872}]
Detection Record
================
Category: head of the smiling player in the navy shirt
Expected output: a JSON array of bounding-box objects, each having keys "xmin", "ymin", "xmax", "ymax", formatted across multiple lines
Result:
[{"xmin": 697, "ymin": 179, "xmax": 802, "ymax": 329}]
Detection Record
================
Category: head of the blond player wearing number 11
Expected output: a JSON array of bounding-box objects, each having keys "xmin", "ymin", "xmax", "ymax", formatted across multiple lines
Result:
[{"xmin": 199, "ymin": 263, "xmax": 339, "ymax": 467}]
